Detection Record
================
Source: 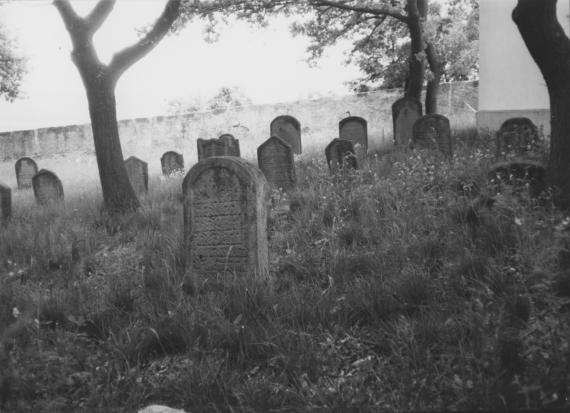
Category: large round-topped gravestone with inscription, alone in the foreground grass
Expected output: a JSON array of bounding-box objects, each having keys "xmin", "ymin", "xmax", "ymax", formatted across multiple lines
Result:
[{"xmin": 182, "ymin": 156, "xmax": 269, "ymax": 277}]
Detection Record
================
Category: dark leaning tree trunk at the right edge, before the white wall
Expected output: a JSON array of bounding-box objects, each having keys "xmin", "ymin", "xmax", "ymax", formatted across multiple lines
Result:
[{"xmin": 513, "ymin": 0, "xmax": 570, "ymax": 209}]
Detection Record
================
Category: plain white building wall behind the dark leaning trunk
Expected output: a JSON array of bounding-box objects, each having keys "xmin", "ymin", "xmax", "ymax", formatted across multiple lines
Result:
[{"xmin": 477, "ymin": 0, "xmax": 570, "ymax": 134}]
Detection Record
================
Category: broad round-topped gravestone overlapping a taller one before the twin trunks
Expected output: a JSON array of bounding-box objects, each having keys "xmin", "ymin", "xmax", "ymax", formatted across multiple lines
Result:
[{"xmin": 412, "ymin": 114, "xmax": 453, "ymax": 159}]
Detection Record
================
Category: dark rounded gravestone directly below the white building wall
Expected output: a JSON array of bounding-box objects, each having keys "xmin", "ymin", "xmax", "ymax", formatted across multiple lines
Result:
[{"xmin": 497, "ymin": 118, "xmax": 539, "ymax": 157}]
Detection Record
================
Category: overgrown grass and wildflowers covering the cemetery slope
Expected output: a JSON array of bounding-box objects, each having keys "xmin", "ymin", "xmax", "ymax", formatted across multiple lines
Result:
[{"xmin": 0, "ymin": 129, "xmax": 570, "ymax": 412}]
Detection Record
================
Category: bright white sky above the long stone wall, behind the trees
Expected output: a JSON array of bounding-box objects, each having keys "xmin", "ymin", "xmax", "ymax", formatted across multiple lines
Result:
[{"xmin": 0, "ymin": 0, "xmax": 359, "ymax": 131}]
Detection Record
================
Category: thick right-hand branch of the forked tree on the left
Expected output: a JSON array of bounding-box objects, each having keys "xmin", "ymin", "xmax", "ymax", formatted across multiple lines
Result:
[{"xmin": 109, "ymin": 0, "xmax": 181, "ymax": 83}]
